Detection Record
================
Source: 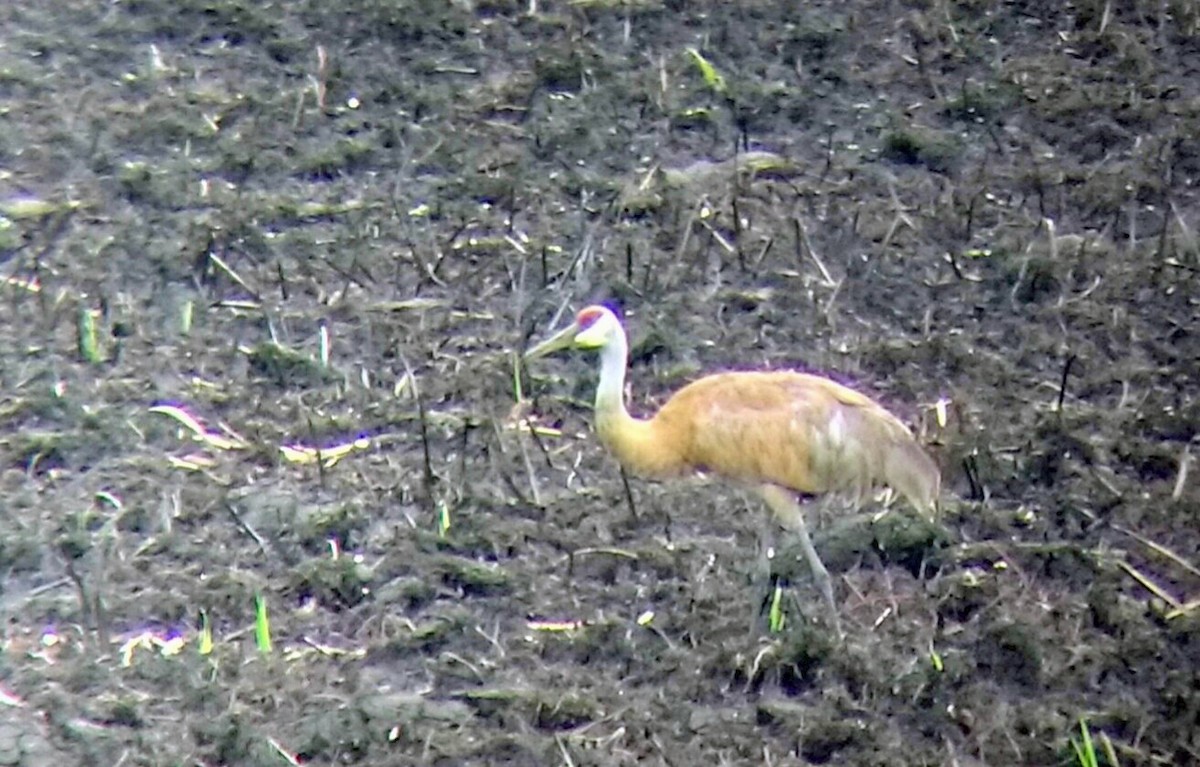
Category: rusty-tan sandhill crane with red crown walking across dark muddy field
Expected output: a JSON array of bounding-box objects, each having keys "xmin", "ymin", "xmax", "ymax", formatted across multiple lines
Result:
[{"xmin": 526, "ymin": 306, "xmax": 941, "ymax": 633}]
